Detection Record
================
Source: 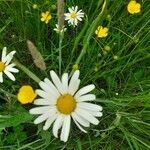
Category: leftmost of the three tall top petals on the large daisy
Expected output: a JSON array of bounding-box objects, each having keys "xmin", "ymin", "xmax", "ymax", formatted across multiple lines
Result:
[{"xmin": 50, "ymin": 70, "xmax": 64, "ymax": 94}]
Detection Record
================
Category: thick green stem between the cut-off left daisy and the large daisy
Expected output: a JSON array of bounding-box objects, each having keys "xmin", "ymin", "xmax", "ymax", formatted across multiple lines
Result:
[{"xmin": 14, "ymin": 59, "xmax": 41, "ymax": 83}]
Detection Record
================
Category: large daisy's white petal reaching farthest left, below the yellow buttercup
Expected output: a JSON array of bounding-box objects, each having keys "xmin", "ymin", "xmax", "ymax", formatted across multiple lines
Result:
[{"xmin": 29, "ymin": 106, "xmax": 53, "ymax": 115}]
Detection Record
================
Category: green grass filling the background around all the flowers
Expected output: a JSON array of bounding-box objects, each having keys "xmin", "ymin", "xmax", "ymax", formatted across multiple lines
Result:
[{"xmin": 0, "ymin": 0, "xmax": 150, "ymax": 150}]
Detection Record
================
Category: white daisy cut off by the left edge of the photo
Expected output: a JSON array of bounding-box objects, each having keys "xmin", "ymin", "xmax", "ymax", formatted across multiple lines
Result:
[{"xmin": 0, "ymin": 47, "xmax": 19, "ymax": 83}]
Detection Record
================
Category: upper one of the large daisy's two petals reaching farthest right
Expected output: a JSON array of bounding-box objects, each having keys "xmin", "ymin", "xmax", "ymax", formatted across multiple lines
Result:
[{"xmin": 77, "ymin": 102, "xmax": 103, "ymax": 111}]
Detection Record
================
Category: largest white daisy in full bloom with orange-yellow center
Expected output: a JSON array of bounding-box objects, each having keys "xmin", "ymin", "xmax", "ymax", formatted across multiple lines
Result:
[{"xmin": 30, "ymin": 70, "xmax": 102, "ymax": 142}]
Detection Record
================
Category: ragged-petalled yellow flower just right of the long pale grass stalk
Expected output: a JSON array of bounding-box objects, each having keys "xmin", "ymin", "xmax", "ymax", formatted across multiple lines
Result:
[{"xmin": 95, "ymin": 26, "xmax": 108, "ymax": 38}]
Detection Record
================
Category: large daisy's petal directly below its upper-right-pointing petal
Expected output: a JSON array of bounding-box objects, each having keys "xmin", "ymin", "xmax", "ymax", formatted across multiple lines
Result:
[{"xmin": 76, "ymin": 94, "xmax": 96, "ymax": 102}]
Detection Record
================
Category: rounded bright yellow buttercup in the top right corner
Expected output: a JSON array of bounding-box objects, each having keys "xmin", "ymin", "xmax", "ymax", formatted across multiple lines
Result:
[{"xmin": 127, "ymin": 0, "xmax": 141, "ymax": 14}]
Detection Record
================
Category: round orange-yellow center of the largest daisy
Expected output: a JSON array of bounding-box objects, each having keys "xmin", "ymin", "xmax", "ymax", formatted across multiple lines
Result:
[{"xmin": 56, "ymin": 94, "xmax": 76, "ymax": 114}]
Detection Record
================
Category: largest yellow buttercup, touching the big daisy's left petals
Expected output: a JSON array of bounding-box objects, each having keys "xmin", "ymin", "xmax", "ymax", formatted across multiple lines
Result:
[{"xmin": 17, "ymin": 85, "xmax": 37, "ymax": 104}]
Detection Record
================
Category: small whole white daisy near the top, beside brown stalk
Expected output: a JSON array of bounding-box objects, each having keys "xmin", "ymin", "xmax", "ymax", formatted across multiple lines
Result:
[{"xmin": 64, "ymin": 6, "xmax": 84, "ymax": 26}]
